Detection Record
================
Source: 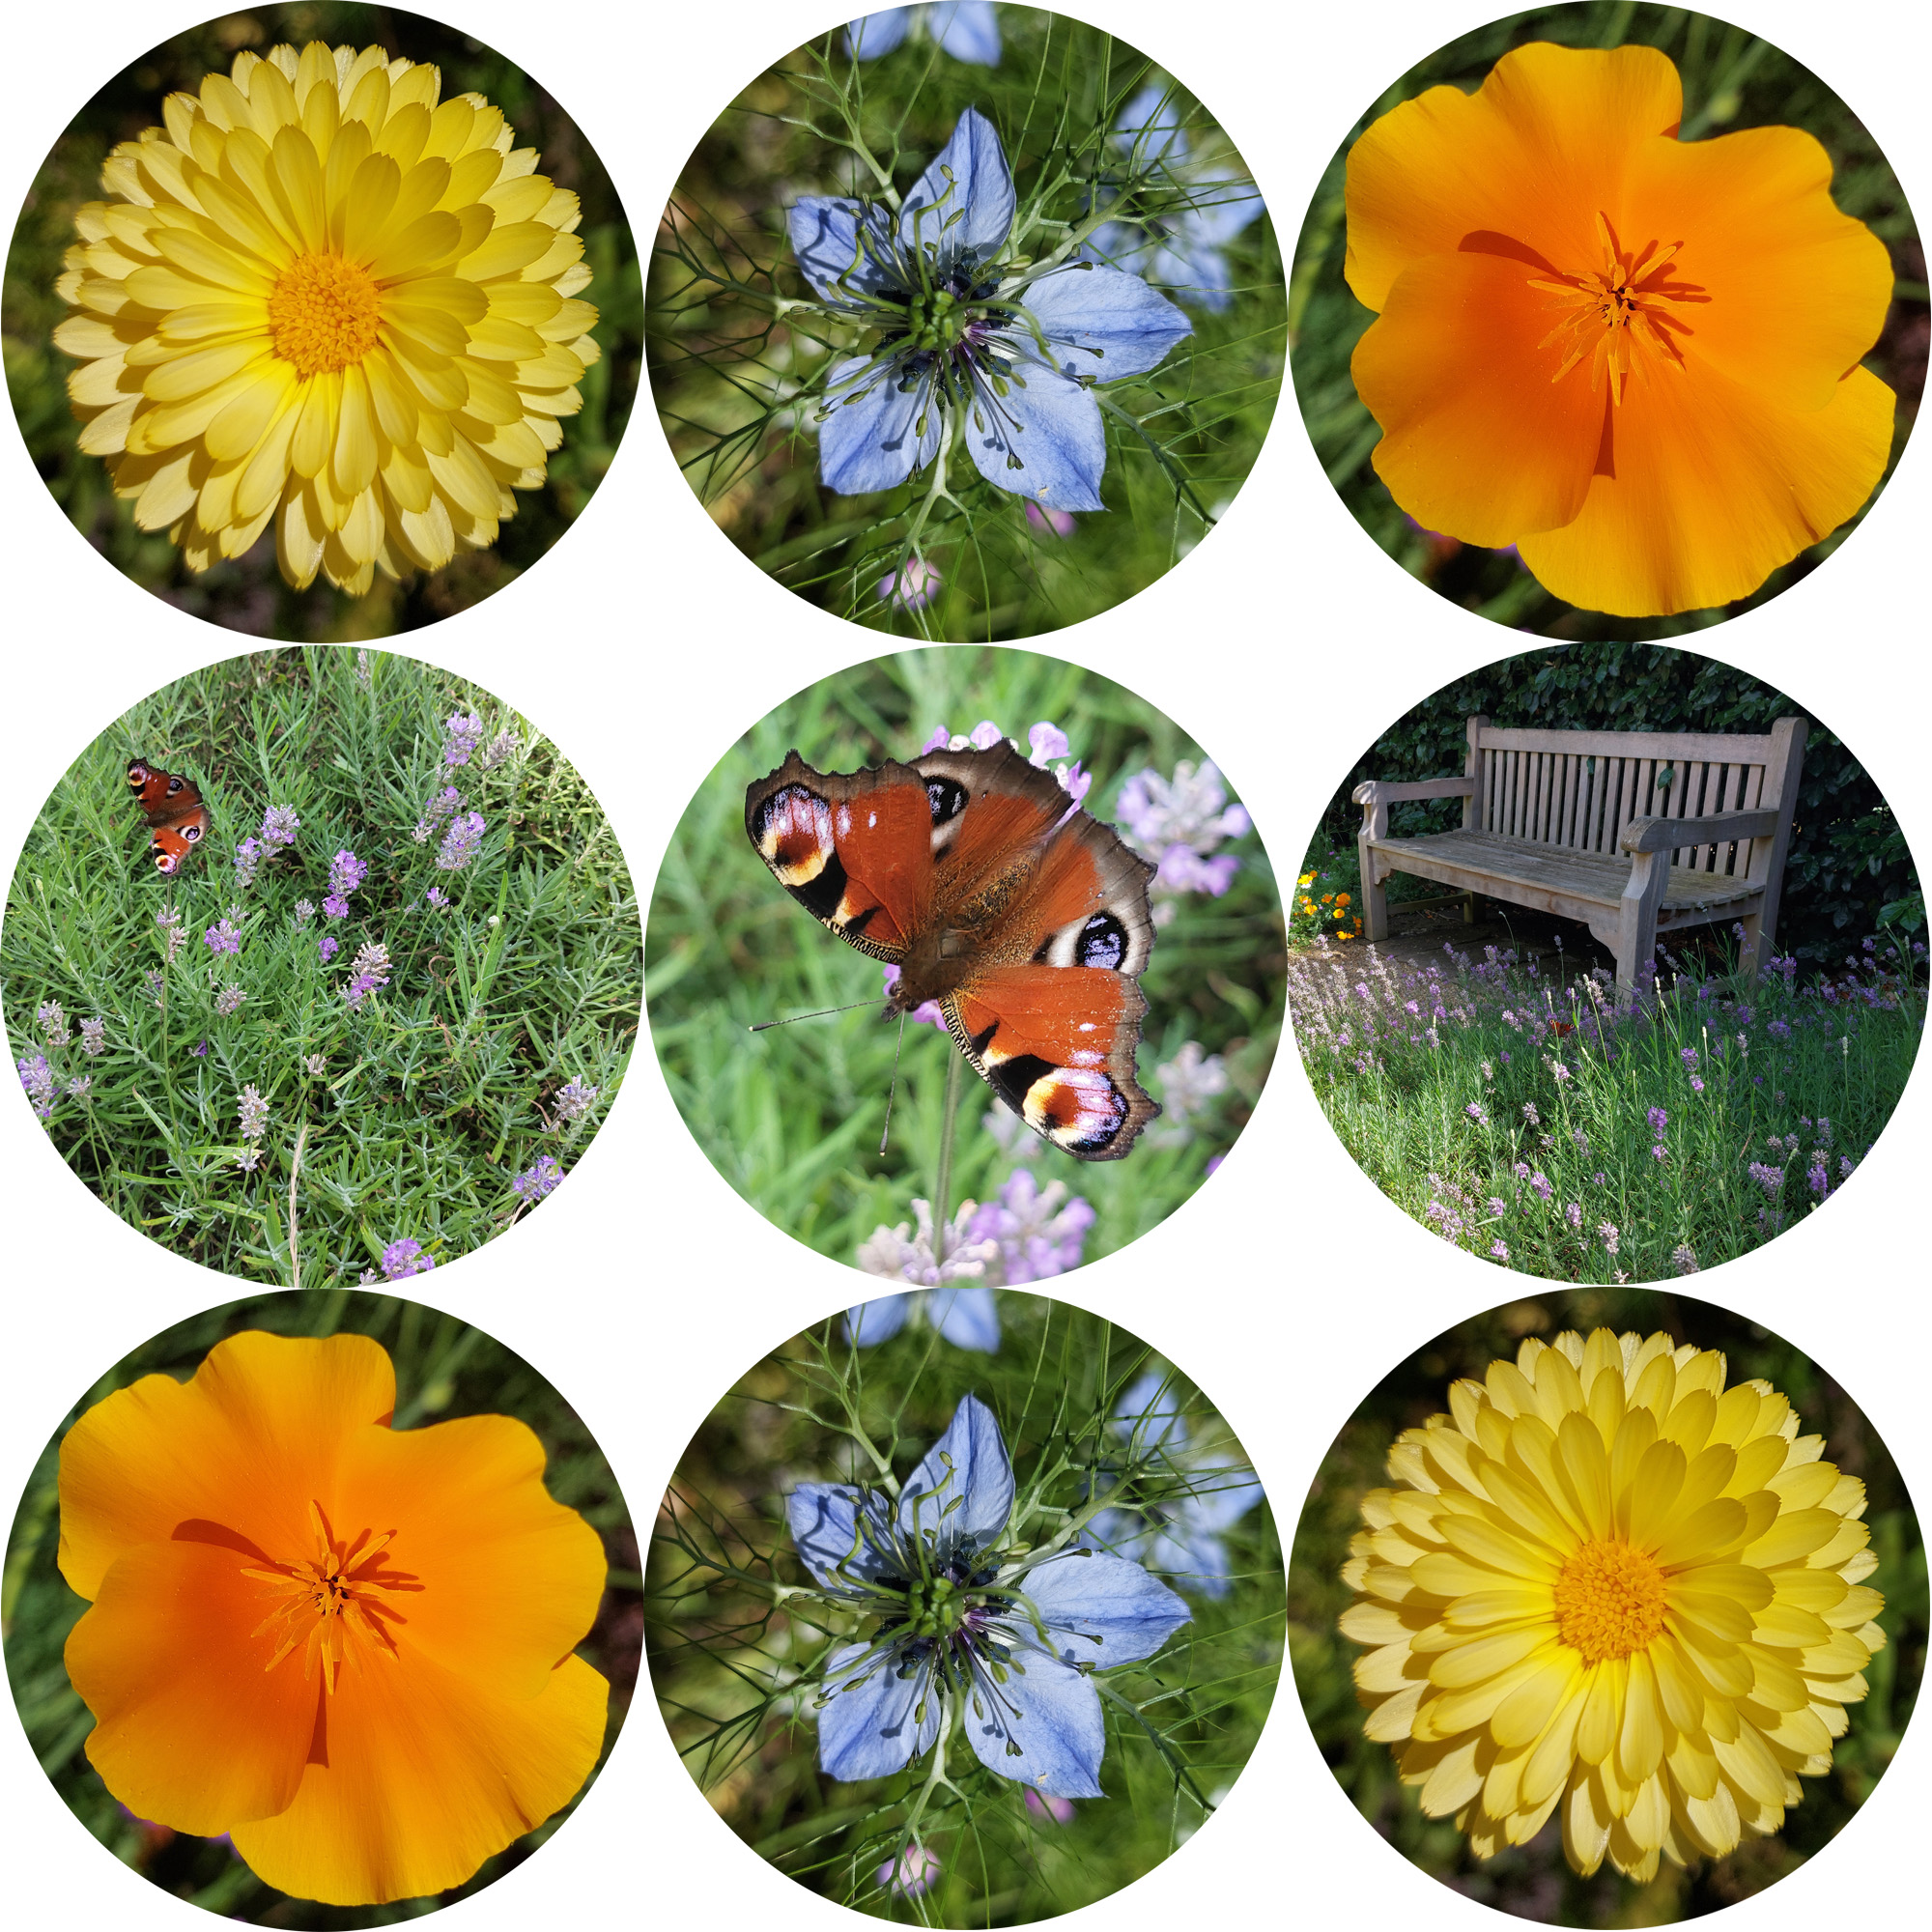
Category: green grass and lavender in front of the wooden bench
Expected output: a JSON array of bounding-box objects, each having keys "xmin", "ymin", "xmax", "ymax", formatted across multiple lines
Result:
[{"xmin": 1291, "ymin": 937, "xmax": 1926, "ymax": 1281}]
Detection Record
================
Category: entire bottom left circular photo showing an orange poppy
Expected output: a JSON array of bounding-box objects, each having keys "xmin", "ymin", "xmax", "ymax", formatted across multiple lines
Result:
[{"xmin": 6, "ymin": 1289, "xmax": 643, "ymax": 1932}]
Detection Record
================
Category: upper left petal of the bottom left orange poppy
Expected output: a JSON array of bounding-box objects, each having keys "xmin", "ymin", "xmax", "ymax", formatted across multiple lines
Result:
[{"xmin": 60, "ymin": 1331, "xmax": 396, "ymax": 1598}]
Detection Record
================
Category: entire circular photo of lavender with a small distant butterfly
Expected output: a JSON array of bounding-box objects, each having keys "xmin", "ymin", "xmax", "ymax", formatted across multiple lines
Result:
[{"xmin": 0, "ymin": 647, "xmax": 643, "ymax": 1289}]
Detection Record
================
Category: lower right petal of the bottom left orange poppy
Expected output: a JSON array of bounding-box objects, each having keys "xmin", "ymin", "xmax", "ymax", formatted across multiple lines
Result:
[{"xmin": 234, "ymin": 1650, "xmax": 611, "ymax": 1905}]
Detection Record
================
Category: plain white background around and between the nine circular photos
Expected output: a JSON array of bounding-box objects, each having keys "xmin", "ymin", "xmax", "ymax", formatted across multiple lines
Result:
[{"xmin": 0, "ymin": 0, "xmax": 1932, "ymax": 1932}]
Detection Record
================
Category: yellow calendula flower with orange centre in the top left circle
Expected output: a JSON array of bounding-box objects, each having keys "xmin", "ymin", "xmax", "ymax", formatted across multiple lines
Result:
[{"xmin": 54, "ymin": 43, "xmax": 599, "ymax": 595}]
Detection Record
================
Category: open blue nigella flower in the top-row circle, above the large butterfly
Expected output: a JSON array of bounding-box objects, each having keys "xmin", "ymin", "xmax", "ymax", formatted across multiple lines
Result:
[{"xmin": 790, "ymin": 108, "xmax": 1194, "ymax": 510}]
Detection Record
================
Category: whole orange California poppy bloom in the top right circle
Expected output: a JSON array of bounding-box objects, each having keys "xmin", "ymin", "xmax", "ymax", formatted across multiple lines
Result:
[{"xmin": 1347, "ymin": 43, "xmax": 1893, "ymax": 616}]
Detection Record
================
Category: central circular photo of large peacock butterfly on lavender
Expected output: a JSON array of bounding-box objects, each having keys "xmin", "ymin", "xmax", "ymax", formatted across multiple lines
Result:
[{"xmin": 645, "ymin": 649, "xmax": 1287, "ymax": 1314}]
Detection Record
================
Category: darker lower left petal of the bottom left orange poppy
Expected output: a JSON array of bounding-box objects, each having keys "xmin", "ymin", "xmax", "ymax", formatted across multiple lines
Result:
[{"xmin": 66, "ymin": 1530, "xmax": 323, "ymax": 1837}]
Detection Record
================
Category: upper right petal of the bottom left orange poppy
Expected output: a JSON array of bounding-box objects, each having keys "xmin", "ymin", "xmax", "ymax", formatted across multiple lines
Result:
[{"xmin": 328, "ymin": 1416, "xmax": 609, "ymax": 1698}]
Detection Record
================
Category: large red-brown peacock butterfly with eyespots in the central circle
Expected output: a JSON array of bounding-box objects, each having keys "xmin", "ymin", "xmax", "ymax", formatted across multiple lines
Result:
[{"xmin": 744, "ymin": 744, "xmax": 1161, "ymax": 1161}]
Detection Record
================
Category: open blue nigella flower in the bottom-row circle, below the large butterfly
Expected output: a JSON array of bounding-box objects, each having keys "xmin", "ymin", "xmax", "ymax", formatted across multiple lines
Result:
[{"xmin": 786, "ymin": 1395, "xmax": 1190, "ymax": 1799}]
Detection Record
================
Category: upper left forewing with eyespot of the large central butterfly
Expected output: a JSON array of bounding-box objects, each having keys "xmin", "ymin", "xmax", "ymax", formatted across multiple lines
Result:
[{"xmin": 744, "ymin": 752, "xmax": 933, "ymax": 962}]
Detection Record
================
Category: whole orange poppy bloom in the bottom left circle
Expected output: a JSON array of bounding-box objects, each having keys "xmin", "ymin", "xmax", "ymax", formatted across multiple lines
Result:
[{"xmin": 60, "ymin": 1333, "xmax": 611, "ymax": 1905}]
